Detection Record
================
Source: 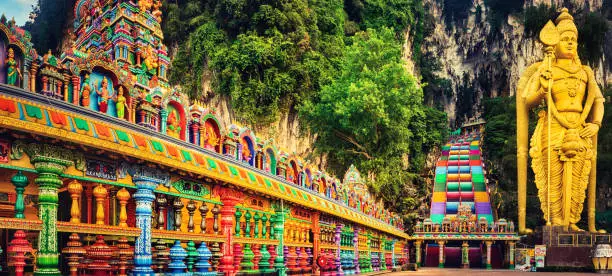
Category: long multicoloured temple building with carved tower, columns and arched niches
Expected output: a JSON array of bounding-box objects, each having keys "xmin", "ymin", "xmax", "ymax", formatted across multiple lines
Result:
[{"xmin": 0, "ymin": 0, "xmax": 410, "ymax": 275}]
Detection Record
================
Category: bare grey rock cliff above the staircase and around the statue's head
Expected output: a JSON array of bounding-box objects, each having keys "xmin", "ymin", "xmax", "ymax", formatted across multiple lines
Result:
[{"xmin": 414, "ymin": 0, "xmax": 612, "ymax": 124}]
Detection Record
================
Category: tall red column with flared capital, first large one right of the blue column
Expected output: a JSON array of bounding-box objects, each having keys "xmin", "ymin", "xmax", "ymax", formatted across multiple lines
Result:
[{"xmin": 213, "ymin": 186, "xmax": 245, "ymax": 275}]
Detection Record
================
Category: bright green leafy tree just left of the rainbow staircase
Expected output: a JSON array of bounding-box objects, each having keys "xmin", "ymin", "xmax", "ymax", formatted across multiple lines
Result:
[{"xmin": 300, "ymin": 27, "xmax": 447, "ymax": 221}]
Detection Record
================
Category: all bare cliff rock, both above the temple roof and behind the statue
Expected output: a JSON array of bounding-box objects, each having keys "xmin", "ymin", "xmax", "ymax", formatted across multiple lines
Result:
[{"xmin": 204, "ymin": 0, "xmax": 612, "ymax": 165}]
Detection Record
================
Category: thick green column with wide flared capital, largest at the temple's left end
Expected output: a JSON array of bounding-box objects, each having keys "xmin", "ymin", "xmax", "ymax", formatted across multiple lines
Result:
[{"xmin": 25, "ymin": 143, "xmax": 74, "ymax": 275}]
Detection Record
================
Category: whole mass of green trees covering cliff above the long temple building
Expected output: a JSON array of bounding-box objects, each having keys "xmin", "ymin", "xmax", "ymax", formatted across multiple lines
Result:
[{"xmin": 163, "ymin": 0, "xmax": 447, "ymax": 222}]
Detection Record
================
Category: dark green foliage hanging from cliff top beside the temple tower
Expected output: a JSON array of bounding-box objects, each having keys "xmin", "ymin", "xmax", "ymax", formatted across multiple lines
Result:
[{"xmin": 165, "ymin": 0, "xmax": 344, "ymax": 124}]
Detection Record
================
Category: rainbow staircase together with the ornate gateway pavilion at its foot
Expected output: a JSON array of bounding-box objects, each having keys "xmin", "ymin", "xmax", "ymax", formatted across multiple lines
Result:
[{"xmin": 412, "ymin": 120, "xmax": 519, "ymax": 269}]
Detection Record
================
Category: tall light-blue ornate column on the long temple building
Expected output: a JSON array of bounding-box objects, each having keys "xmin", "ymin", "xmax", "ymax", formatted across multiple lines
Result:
[{"xmin": 133, "ymin": 176, "xmax": 157, "ymax": 276}]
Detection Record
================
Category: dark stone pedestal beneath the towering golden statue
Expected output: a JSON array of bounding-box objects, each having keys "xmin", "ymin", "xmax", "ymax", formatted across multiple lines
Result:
[{"xmin": 542, "ymin": 226, "xmax": 612, "ymax": 267}]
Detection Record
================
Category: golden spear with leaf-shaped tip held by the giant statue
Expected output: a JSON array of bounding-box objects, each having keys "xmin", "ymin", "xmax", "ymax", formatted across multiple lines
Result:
[{"xmin": 540, "ymin": 20, "xmax": 559, "ymax": 226}]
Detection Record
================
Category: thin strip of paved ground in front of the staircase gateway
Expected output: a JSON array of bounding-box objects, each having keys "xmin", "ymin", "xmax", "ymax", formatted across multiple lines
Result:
[{"xmin": 376, "ymin": 267, "xmax": 596, "ymax": 276}]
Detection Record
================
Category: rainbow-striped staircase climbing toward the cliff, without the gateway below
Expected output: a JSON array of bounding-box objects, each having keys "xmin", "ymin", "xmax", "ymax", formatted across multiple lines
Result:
[{"xmin": 430, "ymin": 132, "xmax": 493, "ymax": 225}]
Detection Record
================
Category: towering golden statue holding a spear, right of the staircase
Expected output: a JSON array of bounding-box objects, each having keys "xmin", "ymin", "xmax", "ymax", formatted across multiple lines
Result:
[{"xmin": 516, "ymin": 8, "xmax": 604, "ymax": 233}]
